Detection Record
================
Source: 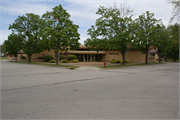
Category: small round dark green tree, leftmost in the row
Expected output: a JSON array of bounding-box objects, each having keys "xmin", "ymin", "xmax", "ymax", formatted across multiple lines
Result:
[{"xmin": 4, "ymin": 33, "xmax": 23, "ymax": 61}]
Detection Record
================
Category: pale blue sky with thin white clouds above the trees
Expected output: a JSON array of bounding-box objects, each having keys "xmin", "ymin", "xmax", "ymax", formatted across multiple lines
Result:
[{"xmin": 0, "ymin": 0, "xmax": 176, "ymax": 44}]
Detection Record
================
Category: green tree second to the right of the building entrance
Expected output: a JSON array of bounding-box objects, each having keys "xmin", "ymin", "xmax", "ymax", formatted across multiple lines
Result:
[{"xmin": 134, "ymin": 11, "xmax": 160, "ymax": 63}]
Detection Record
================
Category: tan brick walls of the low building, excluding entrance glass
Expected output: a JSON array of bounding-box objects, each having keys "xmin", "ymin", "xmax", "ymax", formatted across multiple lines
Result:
[{"xmin": 16, "ymin": 45, "xmax": 156, "ymax": 63}]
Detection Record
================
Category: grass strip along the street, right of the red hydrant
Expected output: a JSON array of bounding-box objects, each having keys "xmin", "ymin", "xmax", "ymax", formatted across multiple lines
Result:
[{"xmin": 99, "ymin": 62, "xmax": 164, "ymax": 69}]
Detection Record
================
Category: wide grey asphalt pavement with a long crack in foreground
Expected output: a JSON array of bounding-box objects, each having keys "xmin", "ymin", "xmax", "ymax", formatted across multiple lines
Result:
[{"xmin": 0, "ymin": 61, "xmax": 179, "ymax": 119}]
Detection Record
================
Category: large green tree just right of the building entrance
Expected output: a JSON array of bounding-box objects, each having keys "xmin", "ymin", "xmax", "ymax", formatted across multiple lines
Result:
[{"xmin": 85, "ymin": 6, "xmax": 135, "ymax": 64}]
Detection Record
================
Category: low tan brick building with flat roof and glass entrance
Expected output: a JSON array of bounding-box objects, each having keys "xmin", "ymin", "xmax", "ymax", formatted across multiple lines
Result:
[{"xmin": 27, "ymin": 45, "xmax": 156, "ymax": 63}]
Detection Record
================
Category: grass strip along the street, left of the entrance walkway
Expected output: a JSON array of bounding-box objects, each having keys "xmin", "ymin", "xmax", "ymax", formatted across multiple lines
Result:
[{"xmin": 9, "ymin": 61, "xmax": 79, "ymax": 68}]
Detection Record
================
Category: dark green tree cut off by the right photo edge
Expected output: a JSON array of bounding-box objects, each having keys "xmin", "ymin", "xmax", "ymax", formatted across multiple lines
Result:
[{"xmin": 166, "ymin": 23, "xmax": 179, "ymax": 62}]
